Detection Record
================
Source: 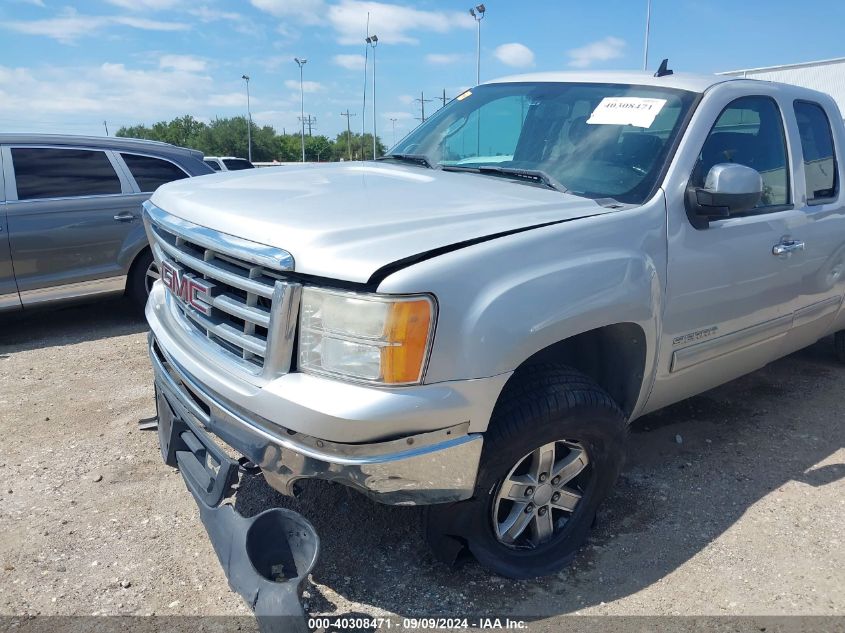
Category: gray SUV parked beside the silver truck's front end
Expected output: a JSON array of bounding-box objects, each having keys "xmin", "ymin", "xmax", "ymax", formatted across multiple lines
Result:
[{"xmin": 0, "ymin": 134, "xmax": 213, "ymax": 312}]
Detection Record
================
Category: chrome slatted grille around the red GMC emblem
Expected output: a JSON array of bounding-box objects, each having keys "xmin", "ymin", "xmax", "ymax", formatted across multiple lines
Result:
[{"xmin": 144, "ymin": 202, "xmax": 301, "ymax": 378}]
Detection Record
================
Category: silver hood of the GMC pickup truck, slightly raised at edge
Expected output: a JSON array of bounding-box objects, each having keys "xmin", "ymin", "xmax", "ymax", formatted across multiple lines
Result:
[{"xmin": 151, "ymin": 162, "xmax": 611, "ymax": 282}]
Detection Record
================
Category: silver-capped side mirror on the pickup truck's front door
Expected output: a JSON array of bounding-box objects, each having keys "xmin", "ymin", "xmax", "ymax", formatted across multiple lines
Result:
[{"xmin": 687, "ymin": 163, "xmax": 763, "ymax": 228}]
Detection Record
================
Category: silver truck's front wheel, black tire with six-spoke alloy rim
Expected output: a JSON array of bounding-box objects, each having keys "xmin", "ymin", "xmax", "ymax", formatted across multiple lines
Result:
[{"xmin": 425, "ymin": 365, "xmax": 627, "ymax": 578}]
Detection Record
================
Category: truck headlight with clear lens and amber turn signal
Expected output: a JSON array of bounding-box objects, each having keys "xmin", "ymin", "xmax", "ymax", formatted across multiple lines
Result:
[{"xmin": 299, "ymin": 288, "xmax": 435, "ymax": 385}]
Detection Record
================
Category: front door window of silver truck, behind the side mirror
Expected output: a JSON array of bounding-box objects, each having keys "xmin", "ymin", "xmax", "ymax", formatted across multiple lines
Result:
[{"xmin": 693, "ymin": 96, "xmax": 789, "ymax": 208}]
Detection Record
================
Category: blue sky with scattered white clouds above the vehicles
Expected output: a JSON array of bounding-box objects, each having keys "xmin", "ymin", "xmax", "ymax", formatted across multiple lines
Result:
[{"xmin": 0, "ymin": 0, "xmax": 845, "ymax": 145}]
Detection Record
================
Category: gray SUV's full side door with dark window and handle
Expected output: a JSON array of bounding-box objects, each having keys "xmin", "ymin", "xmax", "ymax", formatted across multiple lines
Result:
[{"xmin": 3, "ymin": 146, "xmax": 140, "ymax": 306}]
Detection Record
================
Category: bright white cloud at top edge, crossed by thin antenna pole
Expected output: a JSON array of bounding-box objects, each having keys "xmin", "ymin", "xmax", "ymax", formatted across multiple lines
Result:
[{"xmin": 324, "ymin": 0, "xmax": 475, "ymax": 44}]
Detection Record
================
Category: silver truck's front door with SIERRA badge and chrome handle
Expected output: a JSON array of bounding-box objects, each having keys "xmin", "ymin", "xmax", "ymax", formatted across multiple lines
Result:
[{"xmin": 647, "ymin": 91, "xmax": 811, "ymax": 411}]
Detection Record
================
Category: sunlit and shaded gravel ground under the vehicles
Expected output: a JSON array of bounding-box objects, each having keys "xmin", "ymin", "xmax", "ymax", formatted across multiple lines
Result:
[{"xmin": 0, "ymin": 301, "xmax": 845, "ymax": 630}]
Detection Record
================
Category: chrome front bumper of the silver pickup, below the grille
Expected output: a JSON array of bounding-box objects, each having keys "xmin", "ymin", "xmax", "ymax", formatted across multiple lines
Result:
[{"xmin": 150, "ymin": 335, "xmax": 483, "ymax": 505}]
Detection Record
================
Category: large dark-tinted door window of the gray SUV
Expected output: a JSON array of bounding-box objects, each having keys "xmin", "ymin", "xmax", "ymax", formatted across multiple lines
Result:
[{"xmin": 11, "ymin": 147, "xmax": 122, "ymax": 200}]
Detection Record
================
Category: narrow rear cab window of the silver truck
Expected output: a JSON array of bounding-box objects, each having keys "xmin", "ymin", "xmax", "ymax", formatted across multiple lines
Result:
[{"xmin": 795, "ymin": 101, "xmax": 839, "ymax": 204}]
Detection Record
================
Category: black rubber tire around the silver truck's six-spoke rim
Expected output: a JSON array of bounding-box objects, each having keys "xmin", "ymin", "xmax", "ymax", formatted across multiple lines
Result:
[{"xmin": 424, "ymin": 364, "xmax": 627, "ymax": 578}]
